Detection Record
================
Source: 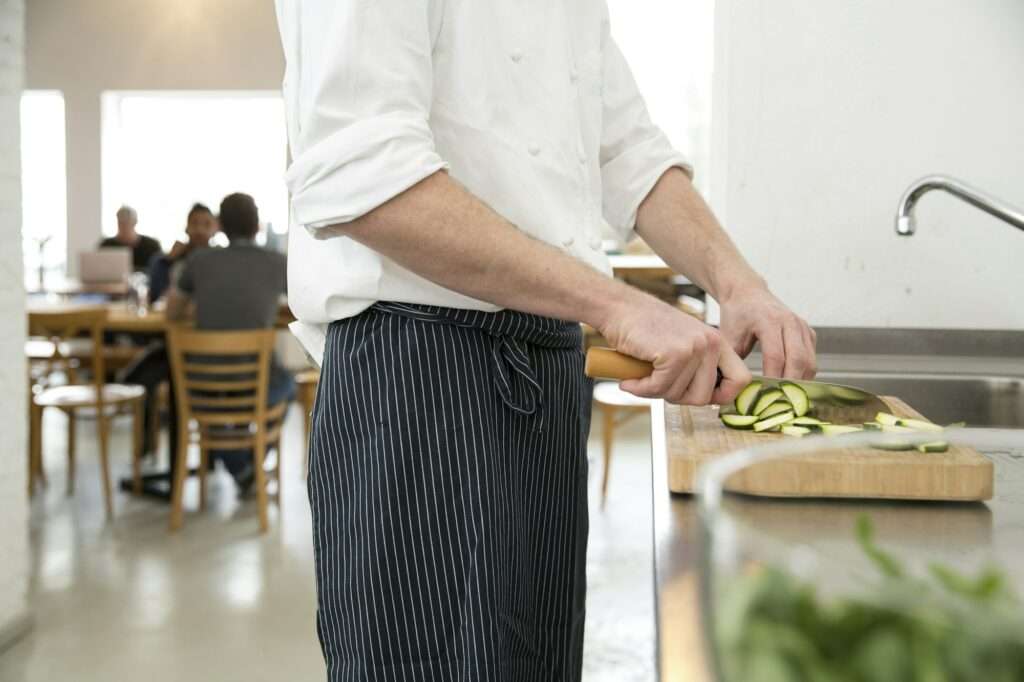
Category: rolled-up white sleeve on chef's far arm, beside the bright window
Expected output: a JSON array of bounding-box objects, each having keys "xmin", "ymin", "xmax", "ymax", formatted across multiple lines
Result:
[{"xmin": 601, "ymin": 35, "xmax": 693, "ymax": 242}]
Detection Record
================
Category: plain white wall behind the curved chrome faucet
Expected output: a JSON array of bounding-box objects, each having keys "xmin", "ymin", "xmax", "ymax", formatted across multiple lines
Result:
[{"xmin": 712, "ymin": 0, "xmax": 1024, "ymax": 329}]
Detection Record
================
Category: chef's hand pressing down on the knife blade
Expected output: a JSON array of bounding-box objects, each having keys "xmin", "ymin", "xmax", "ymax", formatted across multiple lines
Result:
[{"xmin": 720, "ymin": 286, "xmax": 818, "ymax": 379}]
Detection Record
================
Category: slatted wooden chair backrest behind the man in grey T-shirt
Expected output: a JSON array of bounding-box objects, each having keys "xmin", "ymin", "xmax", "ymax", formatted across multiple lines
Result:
[{"xmin": 167, "ymin": 326, "xmax": 284, "ymax": 450}]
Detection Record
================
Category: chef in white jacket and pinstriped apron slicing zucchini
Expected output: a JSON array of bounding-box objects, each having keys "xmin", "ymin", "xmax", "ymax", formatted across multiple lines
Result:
[{"xmin": 276, "ymin": 0, "xmax": 815, "ymax": 682}]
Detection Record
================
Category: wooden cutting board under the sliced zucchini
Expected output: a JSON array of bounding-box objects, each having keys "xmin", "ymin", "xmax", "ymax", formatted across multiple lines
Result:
[{"xmin": 665, "ymin": 397, "xmax": 993, "ymax": 501}]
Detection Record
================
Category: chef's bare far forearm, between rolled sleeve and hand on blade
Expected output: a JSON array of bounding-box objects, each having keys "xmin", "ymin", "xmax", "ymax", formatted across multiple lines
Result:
[{"xmin": 637, "ymin": 168, "xmax": 765, "ymax": 301}]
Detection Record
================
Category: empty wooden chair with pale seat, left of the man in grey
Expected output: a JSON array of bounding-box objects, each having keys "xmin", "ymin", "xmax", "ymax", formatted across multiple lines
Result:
[{"xmin": 29, "ymin": 308, "xmax": 145, "ymax": 518}]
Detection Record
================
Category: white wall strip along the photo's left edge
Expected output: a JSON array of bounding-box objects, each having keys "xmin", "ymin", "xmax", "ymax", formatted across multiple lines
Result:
[{"xmin": 0, "ymin": 0, "xmax": 29, "ymax": 648}]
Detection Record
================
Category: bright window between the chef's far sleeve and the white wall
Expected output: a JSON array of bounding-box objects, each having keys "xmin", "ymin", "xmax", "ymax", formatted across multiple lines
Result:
[{"xmin": 608, "ymin": 0, "xmax": 715, "ymax": 190}]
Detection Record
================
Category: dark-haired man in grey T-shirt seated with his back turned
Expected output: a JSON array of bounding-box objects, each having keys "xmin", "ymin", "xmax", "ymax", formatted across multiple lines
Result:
[{"xmin": 167, "ymin": 194, "xmax": 295, "ymax": 493}]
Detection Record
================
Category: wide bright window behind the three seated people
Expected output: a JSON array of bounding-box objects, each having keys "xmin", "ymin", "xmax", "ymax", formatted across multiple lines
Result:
[{"xmin": 102, "ymin": 92, "xmax": 288, "ymax": 249}]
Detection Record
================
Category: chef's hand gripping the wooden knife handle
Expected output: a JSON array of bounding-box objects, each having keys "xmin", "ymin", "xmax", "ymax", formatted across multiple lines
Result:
[{"xmin": 598, "ymin": 294, "xmax": 751, "ymax": 406}]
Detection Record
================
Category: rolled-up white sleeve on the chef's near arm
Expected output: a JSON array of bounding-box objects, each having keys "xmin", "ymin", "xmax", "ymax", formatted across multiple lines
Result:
[{"xmin": 278, "ymin": 0, "xmax": 445, "ymax": 232}]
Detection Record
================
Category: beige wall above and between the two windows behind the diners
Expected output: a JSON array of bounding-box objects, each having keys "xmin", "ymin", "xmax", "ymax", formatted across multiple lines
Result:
[{"xmin": 26, "ymin": 0, "xmax": 284, "ymax": 266}]
